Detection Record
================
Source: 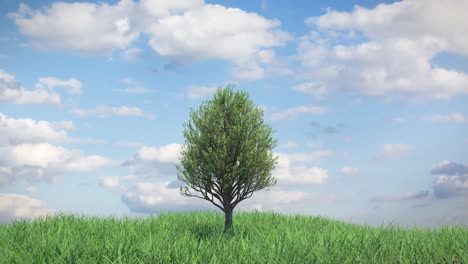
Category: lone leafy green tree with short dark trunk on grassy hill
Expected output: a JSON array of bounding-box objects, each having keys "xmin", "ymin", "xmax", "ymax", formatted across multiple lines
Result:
[{"xmin": 176, "ymin": 85, "xmax": 278, "ymax": 232}]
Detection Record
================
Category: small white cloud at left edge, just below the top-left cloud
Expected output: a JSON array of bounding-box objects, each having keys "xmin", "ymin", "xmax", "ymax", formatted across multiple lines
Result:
[{"xmin": 0, "ymin": 69, "xmax": 60, "ymax": 105}]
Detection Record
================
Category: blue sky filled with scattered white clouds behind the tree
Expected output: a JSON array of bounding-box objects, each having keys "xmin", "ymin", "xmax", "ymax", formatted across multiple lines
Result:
[{"xmin": 0, "ymin": 0, "xmax": 468, "ymax": 228}]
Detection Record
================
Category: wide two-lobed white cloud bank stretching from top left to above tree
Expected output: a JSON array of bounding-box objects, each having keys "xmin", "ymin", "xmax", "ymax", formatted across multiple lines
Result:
[{"xmin": 9, "ymin": 0, "xmax": 291, "ymax": 80}]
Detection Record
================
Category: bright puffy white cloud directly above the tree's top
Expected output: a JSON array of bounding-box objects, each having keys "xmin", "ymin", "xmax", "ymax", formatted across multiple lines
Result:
[{"xmin": 149, "ymin": 4, "xmax": 291, "ymax": 80}]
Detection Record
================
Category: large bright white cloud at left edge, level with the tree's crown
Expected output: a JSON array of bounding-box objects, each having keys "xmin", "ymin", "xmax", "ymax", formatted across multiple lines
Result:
[{"xmin": 0, "ymin": 113, "xmax": 114, "ymax": 186}]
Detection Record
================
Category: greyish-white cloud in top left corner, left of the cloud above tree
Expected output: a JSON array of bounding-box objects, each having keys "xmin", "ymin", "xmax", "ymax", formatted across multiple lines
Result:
[{"xmin": 10, "ymin": 0, "xmax": 139, "ymax": 55}]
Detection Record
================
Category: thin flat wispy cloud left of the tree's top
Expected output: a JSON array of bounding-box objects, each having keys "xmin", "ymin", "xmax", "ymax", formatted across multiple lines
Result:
[{"xmin": 71, "ymin": 105, "xmax": 145, "ymax": 118}]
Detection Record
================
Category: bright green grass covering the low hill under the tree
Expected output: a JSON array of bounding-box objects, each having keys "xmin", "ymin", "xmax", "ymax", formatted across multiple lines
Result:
[{"xmin": 0, "ymin": 211, "xmax": 468, "ymax": 263}]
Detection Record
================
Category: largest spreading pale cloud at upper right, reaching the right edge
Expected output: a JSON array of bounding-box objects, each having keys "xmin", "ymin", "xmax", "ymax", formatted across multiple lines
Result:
[{"xmin": 298, "ymin": 0, "xmax": 468, "ymax": 100}]
